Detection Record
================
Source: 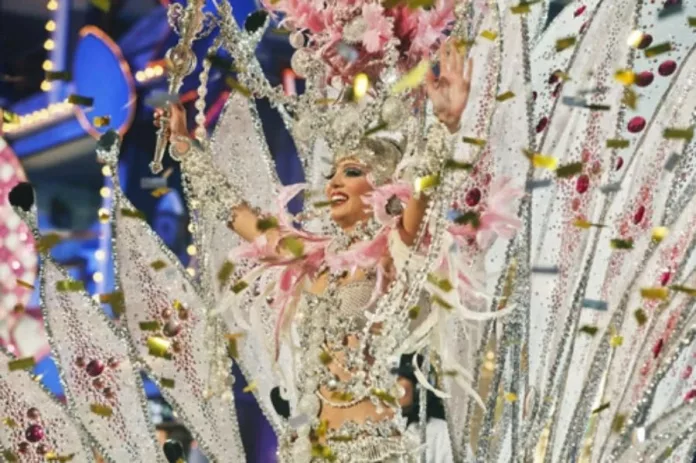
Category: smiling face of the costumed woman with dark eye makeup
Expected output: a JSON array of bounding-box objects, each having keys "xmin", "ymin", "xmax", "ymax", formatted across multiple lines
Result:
[{"xmin": 326, "ymin": 159, "xmax": 372, "ymax": 229}]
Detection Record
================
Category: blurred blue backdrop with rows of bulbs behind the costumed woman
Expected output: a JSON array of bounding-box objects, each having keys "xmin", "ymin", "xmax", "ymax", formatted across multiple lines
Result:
[{"xmin": 0, "ymin": 0, "xmax": 563, "ymax": 462}]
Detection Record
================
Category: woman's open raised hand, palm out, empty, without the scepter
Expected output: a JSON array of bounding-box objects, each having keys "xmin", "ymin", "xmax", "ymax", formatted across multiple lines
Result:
[{"xmin": 425, "ymin": 39, "xmax": 474, "ymax": 132}]
